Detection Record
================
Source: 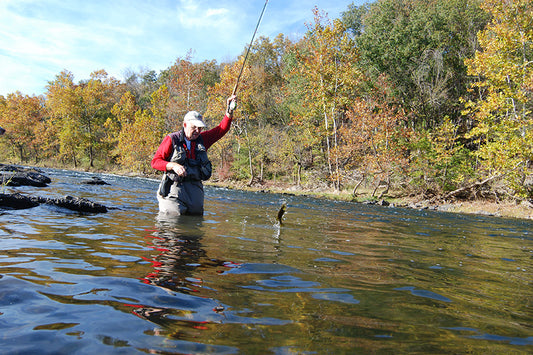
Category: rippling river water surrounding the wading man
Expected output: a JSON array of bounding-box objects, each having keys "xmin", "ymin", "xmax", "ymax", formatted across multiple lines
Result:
[{"xmin": 0, "ymin": 170, "xmax": 533, "ymax": 354}]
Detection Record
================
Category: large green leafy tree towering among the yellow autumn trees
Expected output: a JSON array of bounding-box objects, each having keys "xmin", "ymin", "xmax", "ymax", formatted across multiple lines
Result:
[{"xmin": 356, "ymin": 0, "xmax": 488, "ymax": 128}]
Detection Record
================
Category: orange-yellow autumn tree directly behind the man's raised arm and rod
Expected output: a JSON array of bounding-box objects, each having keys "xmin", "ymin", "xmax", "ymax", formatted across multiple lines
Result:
[{"xmin": 207, "ymin": 35, "xmax": 290, "ymax": 184}]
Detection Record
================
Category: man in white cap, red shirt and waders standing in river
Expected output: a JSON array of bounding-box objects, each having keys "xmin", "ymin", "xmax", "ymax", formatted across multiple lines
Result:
[{"xmin": 152, "ymin": 95, "xmax": 236, "ymax": 215}]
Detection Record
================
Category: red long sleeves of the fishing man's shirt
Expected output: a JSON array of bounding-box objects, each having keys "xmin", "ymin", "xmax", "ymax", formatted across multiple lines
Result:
[{"xmin": 152, "ymin": 115, "xmax": 232, "ymax": 171}]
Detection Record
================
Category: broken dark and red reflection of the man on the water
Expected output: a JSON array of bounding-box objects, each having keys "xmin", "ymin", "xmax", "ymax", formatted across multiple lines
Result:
[{"xmin": 133, "ymin": 213, "xmax": 231, "ymax": 327}]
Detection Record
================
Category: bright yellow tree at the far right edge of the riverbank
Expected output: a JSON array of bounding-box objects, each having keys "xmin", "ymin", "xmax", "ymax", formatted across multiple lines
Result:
[{"xmin": 465, "ymin": 0, "xmax": 533, "ymax": 197}]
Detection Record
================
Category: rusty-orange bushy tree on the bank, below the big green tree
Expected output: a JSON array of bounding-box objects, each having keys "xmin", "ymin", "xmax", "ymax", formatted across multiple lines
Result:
[{"xmin": 335, "ymin": 73, "xmax": 411, "ymax": 195}]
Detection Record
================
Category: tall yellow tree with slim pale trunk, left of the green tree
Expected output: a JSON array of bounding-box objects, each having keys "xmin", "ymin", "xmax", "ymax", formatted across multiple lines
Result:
[{"xmin": 288, "ymin": 8, "xmax": 362, "ymax": 189}]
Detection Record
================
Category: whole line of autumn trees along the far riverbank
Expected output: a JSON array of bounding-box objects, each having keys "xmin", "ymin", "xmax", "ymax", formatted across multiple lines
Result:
[{"xmin": 0, "ymin": 0, "xmax": 533, "ymax": 199}]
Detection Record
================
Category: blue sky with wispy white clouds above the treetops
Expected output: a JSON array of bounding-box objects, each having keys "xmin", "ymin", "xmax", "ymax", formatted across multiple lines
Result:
[{"xmin": 0, "ymin": 0, "xmax": 366, "ymax": 95}]
